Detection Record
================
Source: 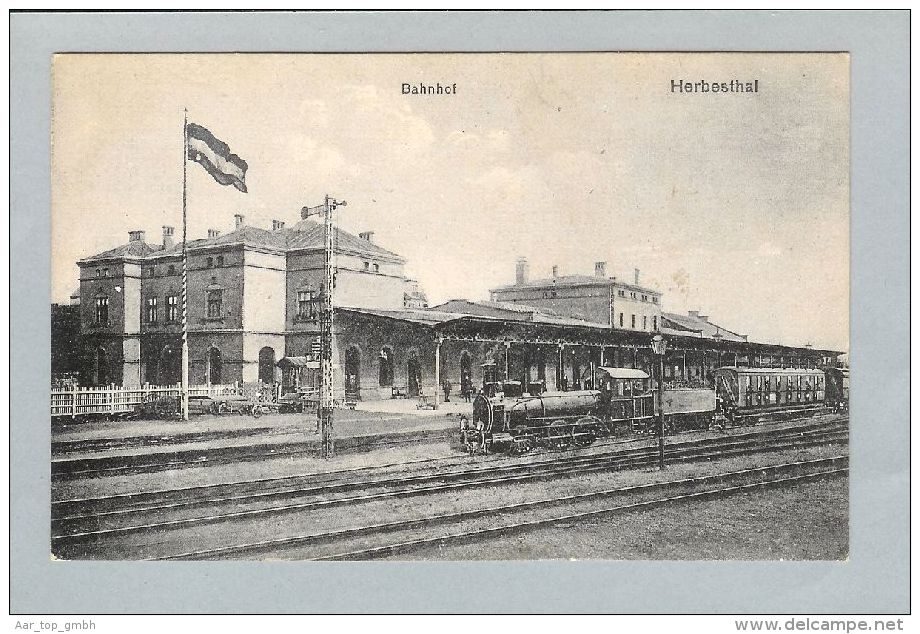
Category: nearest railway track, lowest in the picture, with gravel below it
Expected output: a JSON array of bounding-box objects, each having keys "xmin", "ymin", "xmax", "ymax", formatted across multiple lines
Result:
[{"xmin": 155, "ymin": 456, "xmax": 849, "ymax": 560}]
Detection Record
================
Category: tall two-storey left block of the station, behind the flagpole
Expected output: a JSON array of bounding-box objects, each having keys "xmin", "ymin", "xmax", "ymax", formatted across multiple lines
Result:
[{"xmin": 77, "ymin": 215, "xmax": 427, "ymax": 385}]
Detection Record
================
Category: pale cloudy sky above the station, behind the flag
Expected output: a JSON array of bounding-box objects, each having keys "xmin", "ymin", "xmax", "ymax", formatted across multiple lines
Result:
[{"xmin": 51, "ymin": 53, "xmax": 849, "ymax": 350}]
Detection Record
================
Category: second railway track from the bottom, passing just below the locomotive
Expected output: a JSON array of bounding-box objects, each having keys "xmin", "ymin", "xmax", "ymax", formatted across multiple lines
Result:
[{"xmin": 52, "ymin": 424, "xmax": 847, "ymax": 546}]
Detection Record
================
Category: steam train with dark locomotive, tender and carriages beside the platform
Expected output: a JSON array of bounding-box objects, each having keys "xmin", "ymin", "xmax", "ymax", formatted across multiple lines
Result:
[{"xmin": 460, "ymin": 367, "xmax": 849, "ymax": 452}]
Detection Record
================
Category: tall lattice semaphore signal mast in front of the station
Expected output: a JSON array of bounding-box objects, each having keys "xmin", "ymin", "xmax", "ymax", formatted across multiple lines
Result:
[{"xmin": 303, "ymin": 195, "xmax": 348, "ymax": 459}]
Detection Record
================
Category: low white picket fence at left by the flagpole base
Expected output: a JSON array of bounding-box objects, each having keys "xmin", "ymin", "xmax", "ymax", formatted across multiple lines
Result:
[{"xmin": 51, "ymin": 383, "xmax": 241, "ymax": 417}]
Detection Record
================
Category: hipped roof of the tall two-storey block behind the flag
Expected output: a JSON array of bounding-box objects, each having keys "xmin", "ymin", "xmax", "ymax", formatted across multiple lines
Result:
[{"xmin": 81, "ymin": 220, "xmax": 405, "ymax": 262}]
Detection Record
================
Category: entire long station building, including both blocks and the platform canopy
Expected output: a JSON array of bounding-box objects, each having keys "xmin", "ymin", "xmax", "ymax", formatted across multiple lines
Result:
[{"xmin": 75, "ymin": 211, "xmax": 839, "ymax": 400}]
